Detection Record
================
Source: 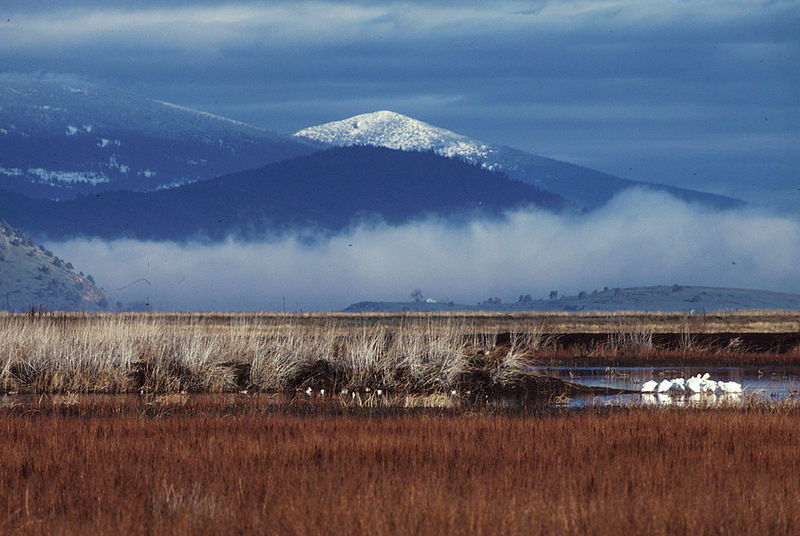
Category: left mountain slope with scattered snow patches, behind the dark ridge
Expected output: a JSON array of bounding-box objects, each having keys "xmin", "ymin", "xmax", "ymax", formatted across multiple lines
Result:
[{"xmin": 0, "ymin": 74, "xmax": 319, "ymax": 198}]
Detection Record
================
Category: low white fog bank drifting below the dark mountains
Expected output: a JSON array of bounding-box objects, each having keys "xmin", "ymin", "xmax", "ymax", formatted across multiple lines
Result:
[{"xmin": 47, "ymin": 190, "xmax": 800, "ymax": 311}]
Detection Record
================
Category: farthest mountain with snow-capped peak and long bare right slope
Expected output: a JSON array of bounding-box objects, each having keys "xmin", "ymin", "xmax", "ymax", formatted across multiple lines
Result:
[{"xmin": 295, "ymin": 110, "xmax": 741, "ymax": 209}]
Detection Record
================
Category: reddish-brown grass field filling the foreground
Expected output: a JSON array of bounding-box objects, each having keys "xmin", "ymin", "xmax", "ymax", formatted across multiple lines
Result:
[{"xmin": 0, "ymin": 395, "xmax": 800, "ymax": 535}]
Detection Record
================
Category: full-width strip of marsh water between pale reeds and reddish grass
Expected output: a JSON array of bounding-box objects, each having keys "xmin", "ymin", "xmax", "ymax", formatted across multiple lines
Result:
[{"xmin": 0, "ymin": 365, "xmax": 800, "ymax": 414}]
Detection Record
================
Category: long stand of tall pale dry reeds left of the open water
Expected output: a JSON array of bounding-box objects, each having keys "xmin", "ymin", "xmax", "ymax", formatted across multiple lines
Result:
[{"xmin": 0, "ymin": 315, "xmax": 548, "ymax": 393}]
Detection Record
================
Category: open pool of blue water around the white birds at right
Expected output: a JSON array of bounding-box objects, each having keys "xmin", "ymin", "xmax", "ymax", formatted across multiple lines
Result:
[{"xmin": 531, "ymin": 366, "xmax": 800, "ymax": 406}]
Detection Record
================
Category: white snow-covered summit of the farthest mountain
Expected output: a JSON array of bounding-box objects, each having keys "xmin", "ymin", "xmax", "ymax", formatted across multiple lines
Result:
[{"xmin": 295, "ymin": 110, "xmax": 495, "ymax": 168}]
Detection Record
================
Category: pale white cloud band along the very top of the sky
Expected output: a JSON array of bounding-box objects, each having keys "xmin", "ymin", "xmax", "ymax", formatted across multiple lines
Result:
[{"xmin": 0, "ymin": 0, "xmax": 793, "ymax": 49}]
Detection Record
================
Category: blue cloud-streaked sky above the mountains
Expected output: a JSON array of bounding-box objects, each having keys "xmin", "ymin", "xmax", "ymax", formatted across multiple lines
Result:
[{"xmin": 0, "ymin": 0, "xmax": 800, "ymax": 209}]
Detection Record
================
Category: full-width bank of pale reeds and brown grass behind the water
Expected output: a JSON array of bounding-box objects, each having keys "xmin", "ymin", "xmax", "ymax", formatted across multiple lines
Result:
[{"xmin": 0, "ymin": 312, "xmax": 800, "ymax": 393}]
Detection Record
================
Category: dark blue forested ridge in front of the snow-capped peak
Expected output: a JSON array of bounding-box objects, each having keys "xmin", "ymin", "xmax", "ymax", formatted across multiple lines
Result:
[{"xmin": 0, "ymin": 147, "xmax": 564, "ymax": 240}]
